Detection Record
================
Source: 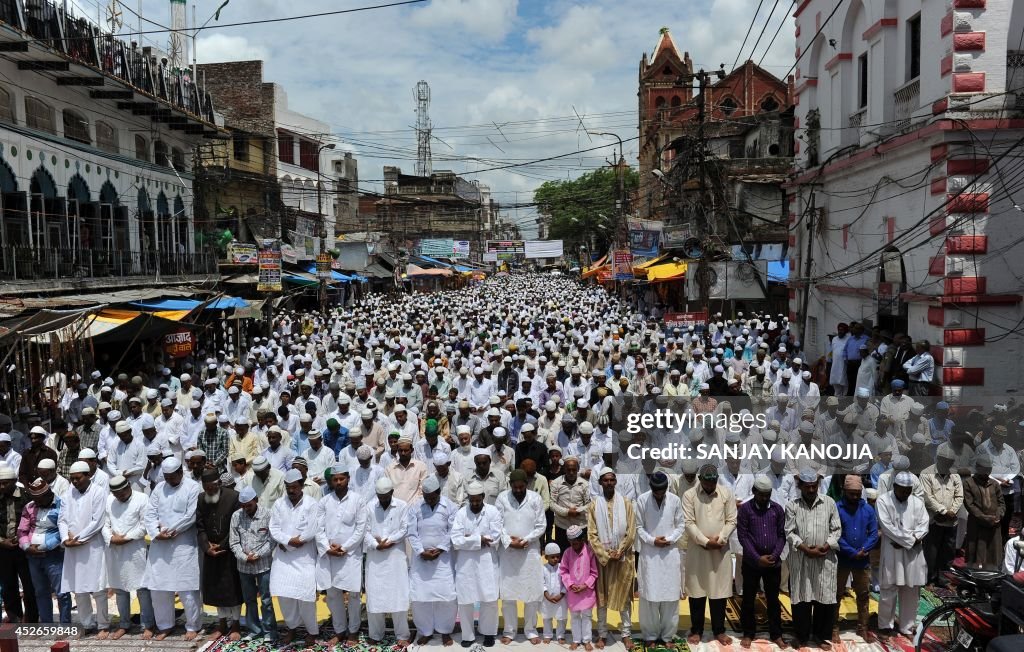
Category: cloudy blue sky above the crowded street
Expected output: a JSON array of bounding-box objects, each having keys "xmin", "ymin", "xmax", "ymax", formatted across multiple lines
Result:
[{"xmin": 97, "ymin": 0, "xmax": 794, "ymax": 234}]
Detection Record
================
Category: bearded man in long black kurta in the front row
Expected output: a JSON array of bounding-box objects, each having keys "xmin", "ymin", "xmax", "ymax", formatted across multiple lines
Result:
[{"xmin": 196, "ymin": 469, "xmax": 243, "ymax": 641}]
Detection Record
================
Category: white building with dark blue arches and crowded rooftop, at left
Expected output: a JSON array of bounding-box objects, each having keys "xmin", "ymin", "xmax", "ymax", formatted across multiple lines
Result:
[{"xmin": 0, "ymin": 0, "xmax": 218, "ymax": 294}]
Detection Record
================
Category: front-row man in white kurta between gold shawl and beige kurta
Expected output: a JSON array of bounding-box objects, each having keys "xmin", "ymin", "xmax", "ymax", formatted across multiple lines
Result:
[{"xmin": 636, "ymin": 471, "xmax": 685, "ymax": 645}]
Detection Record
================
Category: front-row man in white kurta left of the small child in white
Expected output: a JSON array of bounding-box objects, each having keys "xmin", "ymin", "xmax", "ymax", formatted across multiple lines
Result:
[{"xmin": 495, "ymin": 469, "xmax": 548, "ymax": 645}]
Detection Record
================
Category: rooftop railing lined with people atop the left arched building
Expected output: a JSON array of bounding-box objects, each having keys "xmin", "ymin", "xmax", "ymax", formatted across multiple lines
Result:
[{"xmin": 0, "ymin": 0, "xmax": 214, "ymax": 123}]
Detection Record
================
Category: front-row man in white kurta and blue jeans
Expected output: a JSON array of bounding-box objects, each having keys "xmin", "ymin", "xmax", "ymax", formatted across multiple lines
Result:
[{"xmin": 103, "ymin": 475, "xmax": 156, "ymax": 640}]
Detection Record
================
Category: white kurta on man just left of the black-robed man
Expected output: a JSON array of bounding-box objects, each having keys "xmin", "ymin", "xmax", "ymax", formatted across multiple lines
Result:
[{"xmin": 142, "ymin": 476, "xmax": 203, "ymax": 591}]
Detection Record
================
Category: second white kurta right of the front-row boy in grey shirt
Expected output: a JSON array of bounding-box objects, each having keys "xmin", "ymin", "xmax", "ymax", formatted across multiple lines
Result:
[{"xmin": 316, "ymin": 491, "xmax": 367, "ymax": 594}]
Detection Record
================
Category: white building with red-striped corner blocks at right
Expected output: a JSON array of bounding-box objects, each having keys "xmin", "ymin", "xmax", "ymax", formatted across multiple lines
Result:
[{"xmin": 788, "ymin": 0, "xmax": 1024, "ymax": 407}]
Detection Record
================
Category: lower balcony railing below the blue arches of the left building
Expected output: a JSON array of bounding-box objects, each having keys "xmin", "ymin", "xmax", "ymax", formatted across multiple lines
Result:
[{"xmin": 0, "ymin": 247, "xmax": 217, "ymax": 280}]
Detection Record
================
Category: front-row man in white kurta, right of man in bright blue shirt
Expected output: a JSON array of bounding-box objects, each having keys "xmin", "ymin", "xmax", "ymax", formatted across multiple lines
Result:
[{"xmin": 874, "ymin": 471, "xmax": 928, "ymax": 637}]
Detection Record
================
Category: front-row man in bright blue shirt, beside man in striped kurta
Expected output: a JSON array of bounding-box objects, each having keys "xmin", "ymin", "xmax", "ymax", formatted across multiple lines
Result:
[{"xmin": 833, "ymin": 475, "xmax": 879, "ymax": 645}]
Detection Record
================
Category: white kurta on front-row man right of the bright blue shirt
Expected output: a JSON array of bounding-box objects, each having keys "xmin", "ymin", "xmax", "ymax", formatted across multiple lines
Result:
[{"xmin": 874, "ymin": 491, "xmax": 928, "ymax": 586}]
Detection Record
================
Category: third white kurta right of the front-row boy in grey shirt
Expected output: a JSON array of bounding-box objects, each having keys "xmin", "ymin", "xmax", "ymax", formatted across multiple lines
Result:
[{"xmin": 362, "ymin": 497, "xmax": 409, "ymax": 613}]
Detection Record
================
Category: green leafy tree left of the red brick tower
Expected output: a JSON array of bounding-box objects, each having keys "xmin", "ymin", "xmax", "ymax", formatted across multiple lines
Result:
[{"xmin": 534, "ymin": 168, "xmax": 639, "ymax": 253}]
